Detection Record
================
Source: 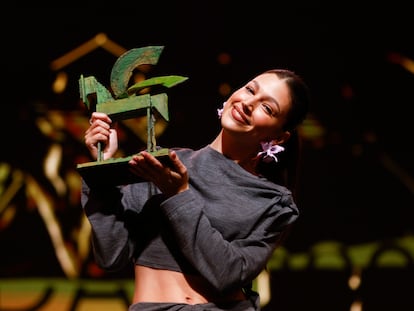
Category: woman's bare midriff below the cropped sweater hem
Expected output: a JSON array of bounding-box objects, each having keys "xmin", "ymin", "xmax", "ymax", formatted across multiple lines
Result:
[{"xmin": 133, "ymin": 265, "xmax": 246, "ymax": 304}]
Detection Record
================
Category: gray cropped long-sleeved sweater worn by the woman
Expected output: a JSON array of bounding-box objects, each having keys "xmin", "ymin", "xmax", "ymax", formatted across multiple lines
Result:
[{"xmin": 81, "ymin": 146, "xmax": 298, "ymax": 292}]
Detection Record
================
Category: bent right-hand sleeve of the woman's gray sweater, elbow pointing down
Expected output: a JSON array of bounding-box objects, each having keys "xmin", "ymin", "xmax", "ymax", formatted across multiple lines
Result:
[{"xmin": 162, "ymin": 190, "xmax": 298, "ymax": 291}]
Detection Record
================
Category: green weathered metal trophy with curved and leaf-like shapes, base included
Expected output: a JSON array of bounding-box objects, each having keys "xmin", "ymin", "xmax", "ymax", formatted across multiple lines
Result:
[{"xmin": 77, "ymin": 46, "xmax": 188, "ymax": 186}]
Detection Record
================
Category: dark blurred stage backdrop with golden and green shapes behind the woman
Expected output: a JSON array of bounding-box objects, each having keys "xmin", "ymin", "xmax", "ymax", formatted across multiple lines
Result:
[{"xmin": 0, "ymin": 1, "xmax": 414, "ymax": 311}]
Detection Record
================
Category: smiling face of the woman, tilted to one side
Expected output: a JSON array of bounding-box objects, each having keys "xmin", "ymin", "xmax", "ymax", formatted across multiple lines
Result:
[{"xmin": 221, "ymin": 73, "xmax": 291, "ymax": 144}]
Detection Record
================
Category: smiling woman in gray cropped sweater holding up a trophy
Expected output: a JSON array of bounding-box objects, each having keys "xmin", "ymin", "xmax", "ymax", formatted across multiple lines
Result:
[{"xmin": 82, "ymin": 70, "xmax": 309, "ymax": 311}]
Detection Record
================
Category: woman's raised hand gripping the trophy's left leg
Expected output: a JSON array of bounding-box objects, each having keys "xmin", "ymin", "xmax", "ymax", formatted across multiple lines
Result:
[{"xmin": 84, "ymin": 112, "xmax": 118, "ymax": 160}]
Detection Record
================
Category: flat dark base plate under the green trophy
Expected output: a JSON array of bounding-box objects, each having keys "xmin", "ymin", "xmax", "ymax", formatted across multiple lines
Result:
[{"xmin": 76, "ymin": 148, "xmax": 171, "ymax": 187}]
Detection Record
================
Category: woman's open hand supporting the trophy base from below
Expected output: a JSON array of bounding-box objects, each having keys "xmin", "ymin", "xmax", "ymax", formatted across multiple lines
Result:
[{"xmin": 129, "ymin": 150, "xmax": 189, "ymax": 197}]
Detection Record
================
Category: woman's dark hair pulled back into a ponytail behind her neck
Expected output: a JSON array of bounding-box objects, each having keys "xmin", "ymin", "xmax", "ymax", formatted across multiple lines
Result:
[{"xmin": 257, "ymin": 69, "xmax": 311, "ymax": 193}]
